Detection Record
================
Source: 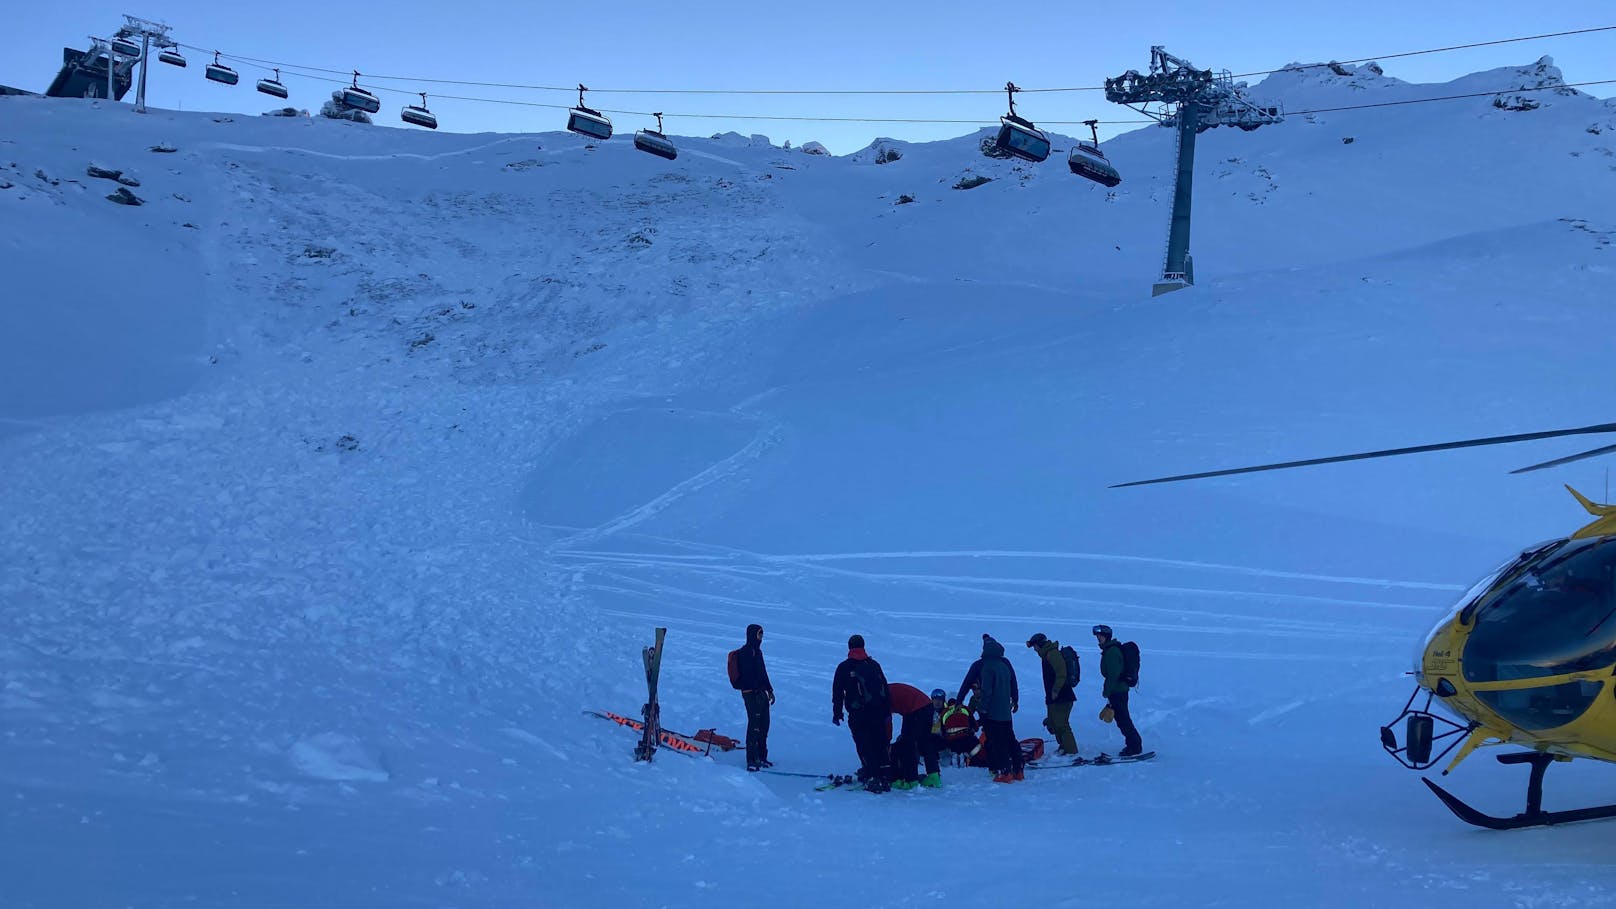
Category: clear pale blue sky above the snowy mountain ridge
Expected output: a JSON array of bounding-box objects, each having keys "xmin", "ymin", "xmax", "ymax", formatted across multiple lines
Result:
[{"xmin": 0, "ymin": 0, "xmax": 1616, "ymax": 154}]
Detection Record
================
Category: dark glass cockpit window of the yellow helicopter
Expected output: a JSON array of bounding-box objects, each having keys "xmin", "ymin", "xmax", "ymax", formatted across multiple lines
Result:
[{"xmin": 1462, "ymin": 537, "xmax": 1616, "ymax": 683}]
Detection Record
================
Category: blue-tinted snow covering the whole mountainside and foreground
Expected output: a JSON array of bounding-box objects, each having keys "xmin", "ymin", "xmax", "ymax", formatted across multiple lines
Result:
[{"xmin": 0, "ymin": 61, "xmax": 1616, "ymax": 909}]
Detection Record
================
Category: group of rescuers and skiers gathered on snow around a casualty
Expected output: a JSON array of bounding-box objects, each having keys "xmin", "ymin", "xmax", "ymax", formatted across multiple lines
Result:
[{"xmin": 730, "ymin": 624, "xmax": 1144, "ymax": 793}]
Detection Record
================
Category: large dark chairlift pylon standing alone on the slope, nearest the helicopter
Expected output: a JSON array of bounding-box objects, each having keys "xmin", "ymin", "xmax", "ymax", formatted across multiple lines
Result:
[{"xmin": 1105, "ymin": 45, "xmax": 1285, "ymax": 296}]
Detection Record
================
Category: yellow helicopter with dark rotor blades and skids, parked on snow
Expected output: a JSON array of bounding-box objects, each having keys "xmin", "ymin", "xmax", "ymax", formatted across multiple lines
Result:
[{"xmin": 1112, "ymin": 424, "xmax": 1616, "ymax": 830}]
